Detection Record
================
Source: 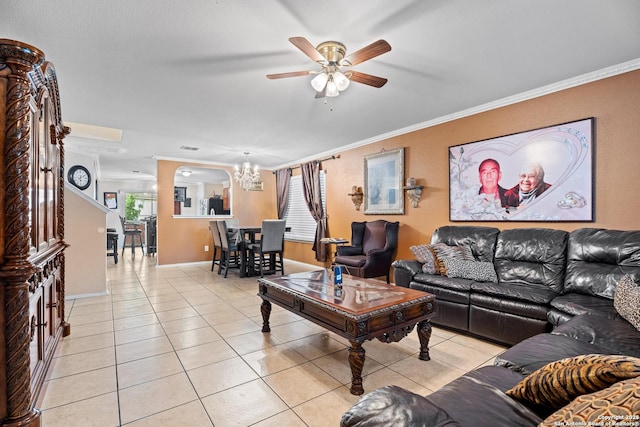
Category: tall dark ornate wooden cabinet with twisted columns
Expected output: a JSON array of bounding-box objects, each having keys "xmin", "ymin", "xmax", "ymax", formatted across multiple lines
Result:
[{"xmin": 0, "ymin": 39, "xmax": 70, "ymax": 426}]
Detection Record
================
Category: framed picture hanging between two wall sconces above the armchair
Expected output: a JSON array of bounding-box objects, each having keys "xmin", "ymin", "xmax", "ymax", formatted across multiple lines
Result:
[{"xmin": 364, "ymin": 147, "xmax": 404, "ymax": 215}]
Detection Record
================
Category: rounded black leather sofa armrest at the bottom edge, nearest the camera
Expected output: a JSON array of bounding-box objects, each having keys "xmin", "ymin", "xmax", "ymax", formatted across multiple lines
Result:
[{"xmin": 340, "ymin": 385, "xmax": 460, "ymax": 427}]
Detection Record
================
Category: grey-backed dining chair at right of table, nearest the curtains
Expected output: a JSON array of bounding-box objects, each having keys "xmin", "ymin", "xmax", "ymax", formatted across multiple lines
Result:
[{"xmin": 249, "ymin": 219, "xmax": 286, "ymax": 277}]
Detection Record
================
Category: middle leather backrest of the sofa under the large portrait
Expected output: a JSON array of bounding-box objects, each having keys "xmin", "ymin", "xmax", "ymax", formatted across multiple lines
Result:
[{"xmin": 493, "ymin": 228, "xmax": 569, "ymax": 293}]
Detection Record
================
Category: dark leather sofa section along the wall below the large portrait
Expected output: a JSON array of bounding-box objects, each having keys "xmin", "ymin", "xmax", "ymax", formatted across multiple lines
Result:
[{"xmin": 393, "ymin": 226, "xmax": 640, "ymax": 345}]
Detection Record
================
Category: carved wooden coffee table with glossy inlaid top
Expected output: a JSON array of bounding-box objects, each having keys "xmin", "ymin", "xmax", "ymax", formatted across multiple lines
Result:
[{"xmin": 258, "ymin": 270, "xmax": 435, "ymax": 395}]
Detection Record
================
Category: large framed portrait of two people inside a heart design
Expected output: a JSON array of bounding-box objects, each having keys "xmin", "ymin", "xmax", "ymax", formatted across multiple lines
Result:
[{"xmin": 449, "ymin": 118, "xmax": 595, "ymax": 222}]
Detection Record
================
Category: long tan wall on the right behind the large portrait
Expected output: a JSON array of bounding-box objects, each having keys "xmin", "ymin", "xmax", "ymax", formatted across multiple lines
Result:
[{"xmin": 316, "ymin": 71, "xmax": 640, "ymax": 258}]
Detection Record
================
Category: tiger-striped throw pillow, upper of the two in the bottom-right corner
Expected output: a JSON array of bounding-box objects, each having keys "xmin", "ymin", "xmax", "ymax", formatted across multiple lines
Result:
[{"xmin": 506, "ymin": 354, "xmax": 640, "ymax": 409}]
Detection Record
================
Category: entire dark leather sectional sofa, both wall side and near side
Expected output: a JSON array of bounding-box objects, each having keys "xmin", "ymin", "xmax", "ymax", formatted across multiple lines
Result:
[{"xmin": 341, "ymin": 226, "xmax": 640, "ymax": 427}]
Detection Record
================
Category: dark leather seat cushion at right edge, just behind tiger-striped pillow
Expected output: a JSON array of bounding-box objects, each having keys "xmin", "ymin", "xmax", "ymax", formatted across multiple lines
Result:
[{"xmin": 551, "ymin": 314, "xmax": 640, "ymax": 357}]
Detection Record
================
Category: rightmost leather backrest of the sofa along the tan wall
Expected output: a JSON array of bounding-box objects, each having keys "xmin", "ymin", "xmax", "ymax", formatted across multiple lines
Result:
[{"xmin": 564, "ymin": 228, "xmax": 640, "ymax": 299}]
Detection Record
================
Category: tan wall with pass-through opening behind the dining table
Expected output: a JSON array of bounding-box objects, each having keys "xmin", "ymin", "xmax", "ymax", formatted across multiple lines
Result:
[{"xmin": 157, "ymin": 160, "xmax": 276, "ymax": 265}]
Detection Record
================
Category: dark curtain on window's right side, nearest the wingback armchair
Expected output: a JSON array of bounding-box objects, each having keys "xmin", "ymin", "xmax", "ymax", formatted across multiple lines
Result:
[{"xmin": 300, "ymin": 161, "xmax": 327, "ymax": 262}]
